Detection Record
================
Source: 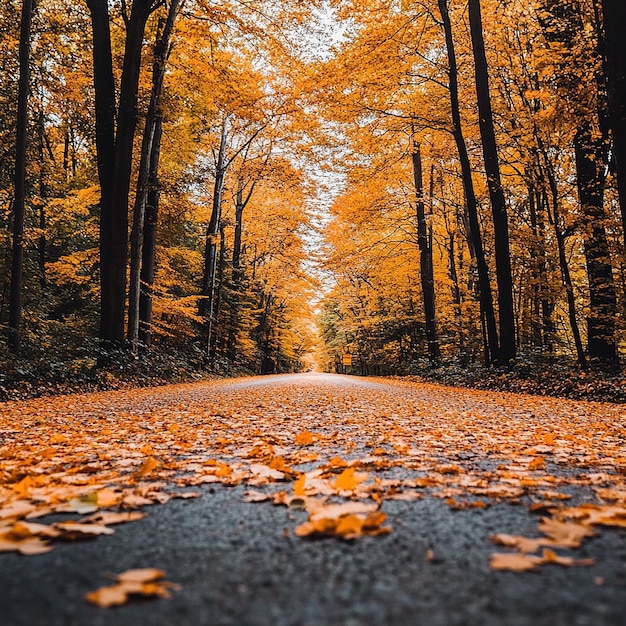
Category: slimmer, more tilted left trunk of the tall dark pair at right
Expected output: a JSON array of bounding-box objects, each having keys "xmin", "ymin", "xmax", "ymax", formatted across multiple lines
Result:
[{"xmin": 437, "ymin": 0, "xmax": 500, "ymax": 362}]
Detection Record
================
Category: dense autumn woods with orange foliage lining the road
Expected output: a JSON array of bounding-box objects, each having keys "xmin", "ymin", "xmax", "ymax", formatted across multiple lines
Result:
[{"xmin": 0, "ymin": 0, "xmax": 626, "ymax": 385}]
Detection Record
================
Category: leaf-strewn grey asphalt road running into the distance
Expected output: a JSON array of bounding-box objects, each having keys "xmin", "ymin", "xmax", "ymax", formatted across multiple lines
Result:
[{"xmin": 0, "ymin": 374, "xmax": 626, "ymax": 626}]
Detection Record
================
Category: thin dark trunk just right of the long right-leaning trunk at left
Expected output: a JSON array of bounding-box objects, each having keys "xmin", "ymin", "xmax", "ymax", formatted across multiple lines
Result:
[{"xmin": 139, "ymin": 115, "xmax": 163, "ymax": 347}]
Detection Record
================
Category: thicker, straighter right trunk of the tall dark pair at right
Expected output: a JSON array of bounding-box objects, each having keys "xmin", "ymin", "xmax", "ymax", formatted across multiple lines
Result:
[{"xmin": 469, "ymin": 0, "xmax": 516, "ymax": 365}]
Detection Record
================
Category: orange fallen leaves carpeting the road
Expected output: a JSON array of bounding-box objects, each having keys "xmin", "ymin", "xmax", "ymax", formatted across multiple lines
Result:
[{"xmin": 0, "ymin": 376, "xmax": 626, "ymax": 605}]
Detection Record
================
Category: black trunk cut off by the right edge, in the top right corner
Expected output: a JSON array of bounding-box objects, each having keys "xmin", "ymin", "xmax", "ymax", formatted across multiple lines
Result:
[{"xmin": 602, "ymin": 0, "xmax": 626, "ymax": 241}]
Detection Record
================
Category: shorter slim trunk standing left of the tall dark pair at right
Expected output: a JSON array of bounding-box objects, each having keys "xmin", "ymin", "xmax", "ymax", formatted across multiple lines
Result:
[{"xmin": 411, "ymin": 141, "xmax": 441, "ymax": 363}]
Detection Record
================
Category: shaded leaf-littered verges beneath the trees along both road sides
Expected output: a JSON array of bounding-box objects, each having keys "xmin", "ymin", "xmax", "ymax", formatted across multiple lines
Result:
[{"xmin": 0, "ymin": 349, "xmax": 626, "ymax": 404}]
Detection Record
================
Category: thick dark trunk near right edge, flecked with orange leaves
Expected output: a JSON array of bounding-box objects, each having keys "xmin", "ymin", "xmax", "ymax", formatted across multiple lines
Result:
[{"xmin": 574, "ymin": 122, "xmax": 618, "ymax": 367}]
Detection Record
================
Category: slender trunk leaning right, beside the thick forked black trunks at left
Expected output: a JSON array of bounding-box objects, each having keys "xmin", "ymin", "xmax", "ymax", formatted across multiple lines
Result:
[{"xmin": 127, "ymin": 0, "xmax": 179, "ymax": 352}]
